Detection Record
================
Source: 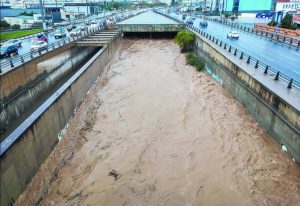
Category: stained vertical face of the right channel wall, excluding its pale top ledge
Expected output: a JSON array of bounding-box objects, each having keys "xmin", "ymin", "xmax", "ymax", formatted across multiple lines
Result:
[{"xmin": 195, "ymin": 35, "xmax": 300, "ymax": 163}]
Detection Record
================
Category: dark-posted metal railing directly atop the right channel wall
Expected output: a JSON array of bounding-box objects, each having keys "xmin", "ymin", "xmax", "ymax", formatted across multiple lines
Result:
[{"xmin": 186, "ymin": 24, "xmax": 300, "ymax": 89}]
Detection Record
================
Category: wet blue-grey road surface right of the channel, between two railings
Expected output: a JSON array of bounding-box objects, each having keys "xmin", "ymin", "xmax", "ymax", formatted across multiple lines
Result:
[{"xmin": 171, "ymin": 13, "xmax": 300, "ymax": 82}]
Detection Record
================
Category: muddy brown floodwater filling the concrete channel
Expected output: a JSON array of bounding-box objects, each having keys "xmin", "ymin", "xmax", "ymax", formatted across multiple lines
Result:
[{"xmin": 16, "ymin": 40, "xmax": 300, "ymax": 206}]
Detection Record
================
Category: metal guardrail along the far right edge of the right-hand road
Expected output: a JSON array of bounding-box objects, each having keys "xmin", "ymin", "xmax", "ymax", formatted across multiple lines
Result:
[{"xmin": 200, "ymin": 16, "xmax": 300, "ymax": 48}]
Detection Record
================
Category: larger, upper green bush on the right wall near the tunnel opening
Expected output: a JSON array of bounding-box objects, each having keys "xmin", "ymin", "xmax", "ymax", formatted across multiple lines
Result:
[{"xmin": 174, "ymin": 29, "xmax": 195, "ymax": 52}]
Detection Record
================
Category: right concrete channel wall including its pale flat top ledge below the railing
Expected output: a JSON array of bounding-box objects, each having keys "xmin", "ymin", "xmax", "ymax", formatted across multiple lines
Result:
[{"xmin": 195, "ymin": 29, "xmax": 300, "ymax": 162}]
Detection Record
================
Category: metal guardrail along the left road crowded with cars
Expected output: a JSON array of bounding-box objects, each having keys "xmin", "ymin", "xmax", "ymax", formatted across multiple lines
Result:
[{"xmin": 0, "ymin": 26, "xmax": 104, "ymax": 75}]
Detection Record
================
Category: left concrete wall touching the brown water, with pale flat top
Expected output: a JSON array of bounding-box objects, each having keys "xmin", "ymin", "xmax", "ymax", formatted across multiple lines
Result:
[{"xmin": 1, "ymin": 33, "xmax": 121, "ymax": 206}]
